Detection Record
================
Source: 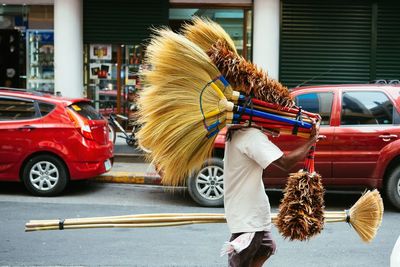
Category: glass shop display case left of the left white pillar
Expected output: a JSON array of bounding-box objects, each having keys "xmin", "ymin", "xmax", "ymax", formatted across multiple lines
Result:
[{"xmin": 26, "ymin": 30, "xmax": 54, "ymax": 93}]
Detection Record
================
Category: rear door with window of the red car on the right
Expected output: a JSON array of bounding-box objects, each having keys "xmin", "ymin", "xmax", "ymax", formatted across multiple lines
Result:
[{"xmin": 332, "ymin": 89, "xmax": 399, "ymax": 187}]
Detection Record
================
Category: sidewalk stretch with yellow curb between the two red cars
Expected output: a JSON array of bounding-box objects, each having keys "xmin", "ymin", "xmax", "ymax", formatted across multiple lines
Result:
[{"xmin": 93, "ymin": 138, "xmax": 161, "ymax": 185}]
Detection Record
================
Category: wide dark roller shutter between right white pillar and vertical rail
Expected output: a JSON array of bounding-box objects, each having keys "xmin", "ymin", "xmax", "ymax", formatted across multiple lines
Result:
[{"xmin": 280, "ymin": 0, "xmax": 372, "ymax": 87}]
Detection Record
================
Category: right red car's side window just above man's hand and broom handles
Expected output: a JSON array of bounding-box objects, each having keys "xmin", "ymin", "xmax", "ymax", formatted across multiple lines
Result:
[{"xmin": 295, "ymin": 92, "xmax": 333, "ymax": 125}]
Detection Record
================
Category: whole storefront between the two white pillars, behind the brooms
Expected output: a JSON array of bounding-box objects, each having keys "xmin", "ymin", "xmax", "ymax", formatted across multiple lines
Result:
[{"xmin": 83, "ymin": 0, "xmax": 252, "ymax": 118}]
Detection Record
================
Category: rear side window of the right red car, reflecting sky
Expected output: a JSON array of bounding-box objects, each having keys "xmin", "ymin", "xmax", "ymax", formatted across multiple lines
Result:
[{"xmin": 340, "ymin": 91, "xmax": 399, "ymax": 125}]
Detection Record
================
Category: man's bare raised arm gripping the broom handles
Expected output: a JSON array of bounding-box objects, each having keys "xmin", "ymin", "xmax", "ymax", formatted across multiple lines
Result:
[{"xmin": 272, "ymin": 123, "xmax": 319, "ymax": 171}]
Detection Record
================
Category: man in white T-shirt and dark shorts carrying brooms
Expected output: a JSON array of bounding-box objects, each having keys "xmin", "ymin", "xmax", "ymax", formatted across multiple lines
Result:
[{"xmin": 224, "ymin": 120, "xmax": 319, "ymax": 267}]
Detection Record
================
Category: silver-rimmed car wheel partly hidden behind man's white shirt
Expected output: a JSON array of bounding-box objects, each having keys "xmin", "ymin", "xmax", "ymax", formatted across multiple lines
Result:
[{"xmin": 188, "ymin": 158, "xmax": 224, "ymax": 207}]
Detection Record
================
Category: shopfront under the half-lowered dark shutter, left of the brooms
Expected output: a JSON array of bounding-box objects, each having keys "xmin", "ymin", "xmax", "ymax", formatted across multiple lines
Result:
[{"xmin": 83, "ymin": 0, "xmax": 169, "ymax": 117}]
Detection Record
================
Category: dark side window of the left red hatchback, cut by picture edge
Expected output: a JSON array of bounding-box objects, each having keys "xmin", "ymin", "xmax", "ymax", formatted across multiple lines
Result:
[{"xmin": 0, "ymin": 97, "xmax": 36, "ymax": 121}]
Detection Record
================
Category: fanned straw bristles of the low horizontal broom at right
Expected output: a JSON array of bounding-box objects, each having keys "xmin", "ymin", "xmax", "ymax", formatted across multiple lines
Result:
[{"xmin": 349, "ymin": 189, "xmax": 384, "ymax": 242}]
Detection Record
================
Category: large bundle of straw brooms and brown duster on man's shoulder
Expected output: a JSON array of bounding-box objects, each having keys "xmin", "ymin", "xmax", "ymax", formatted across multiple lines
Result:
[{"xmin": 137, "ymin": 19, "xmax": 319, "ymax": 186}]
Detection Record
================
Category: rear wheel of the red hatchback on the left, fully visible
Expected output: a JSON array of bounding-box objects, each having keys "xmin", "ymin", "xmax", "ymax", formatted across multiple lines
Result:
[{"xmin": 22, "ymin": 155, "xmax": 68, "ymax": 196}]
